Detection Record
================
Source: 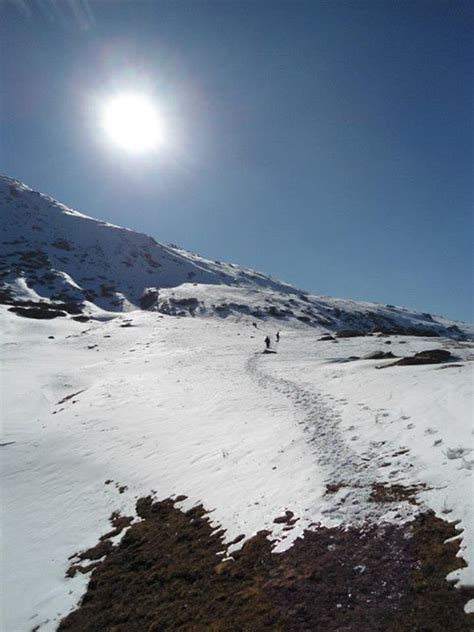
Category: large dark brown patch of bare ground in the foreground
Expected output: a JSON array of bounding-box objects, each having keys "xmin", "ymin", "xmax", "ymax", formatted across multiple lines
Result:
[{"xmin": 59, "ymin": 497, "xmax": 474, "ymax": 632}]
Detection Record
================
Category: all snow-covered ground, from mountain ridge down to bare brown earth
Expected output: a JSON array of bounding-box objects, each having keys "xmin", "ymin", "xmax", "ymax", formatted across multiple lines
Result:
[{"xmin": 0, "ymin": 178, "xmax": 474, "ymax": 632}]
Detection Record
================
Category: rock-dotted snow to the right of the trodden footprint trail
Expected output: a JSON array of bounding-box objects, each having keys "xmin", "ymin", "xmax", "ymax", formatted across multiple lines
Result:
[{"xmin": 266, "ymin": 332, "xmax": 474, "ymax": 586}]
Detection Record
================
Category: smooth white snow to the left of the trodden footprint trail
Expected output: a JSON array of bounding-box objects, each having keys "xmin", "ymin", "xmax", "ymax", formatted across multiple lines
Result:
[{"xmin": 1, "ymin": 312, "xmax": 324, "ymax": 632}]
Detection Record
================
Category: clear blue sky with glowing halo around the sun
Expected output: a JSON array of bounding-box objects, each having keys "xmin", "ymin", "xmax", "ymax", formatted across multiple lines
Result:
[{"xmin": 0, "ymin": 0, "xmax": 474, "ymax": 321}]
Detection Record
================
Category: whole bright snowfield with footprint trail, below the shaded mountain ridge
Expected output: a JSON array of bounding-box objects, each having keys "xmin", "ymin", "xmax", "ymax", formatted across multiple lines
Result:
[{"xmin": 0, "ymin": 306, "xmax": 474, "ymax": 632}]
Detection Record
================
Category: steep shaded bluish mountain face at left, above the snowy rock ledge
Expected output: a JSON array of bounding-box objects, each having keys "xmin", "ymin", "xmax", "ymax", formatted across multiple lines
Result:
[{"xmin": 0, "ymin": 177, "xmax": 293, "ymax": 311}]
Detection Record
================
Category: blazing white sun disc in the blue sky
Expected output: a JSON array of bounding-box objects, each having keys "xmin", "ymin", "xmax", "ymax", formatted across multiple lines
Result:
[{"xmin": 102, "ymin": 94, "xmax": 164, "ymax": 154}]
